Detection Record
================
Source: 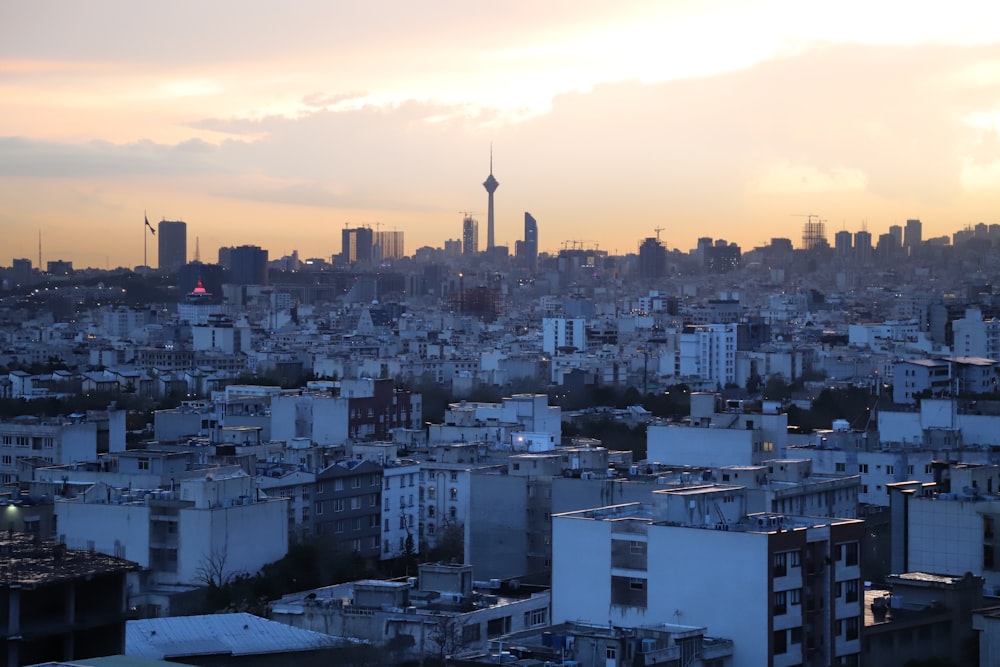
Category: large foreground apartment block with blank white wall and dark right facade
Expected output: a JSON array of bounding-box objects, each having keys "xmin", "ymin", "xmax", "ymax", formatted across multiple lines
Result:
[{"xmin": 552, "ymin": 486, "xmax": 864, "ymax": 667}]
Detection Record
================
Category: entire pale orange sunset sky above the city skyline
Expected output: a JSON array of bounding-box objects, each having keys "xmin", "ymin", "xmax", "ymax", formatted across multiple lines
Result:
[{"xmin": 0, "ymin": 0, "xmax": 1000, "ymax": 268}]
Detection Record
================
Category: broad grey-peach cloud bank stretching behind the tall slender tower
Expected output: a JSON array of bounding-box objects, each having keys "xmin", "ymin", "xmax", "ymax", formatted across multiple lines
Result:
[{"xmin": 0, "ymin": 39, "xmax": 1000, "ymax": 260}]
